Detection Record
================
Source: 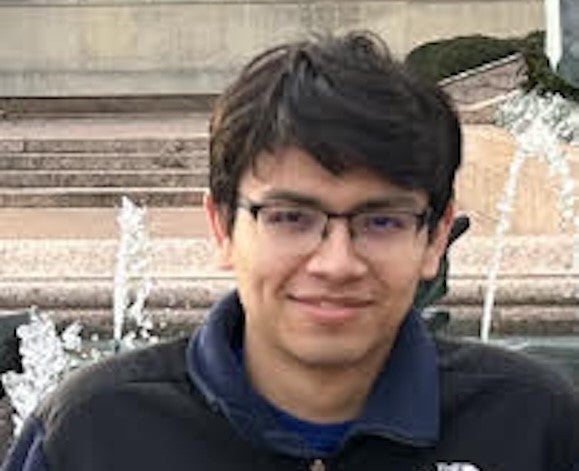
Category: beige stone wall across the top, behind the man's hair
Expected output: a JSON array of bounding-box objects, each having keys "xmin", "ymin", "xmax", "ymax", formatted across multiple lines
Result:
[{"xmin": 0, "ymin": 0, "xmax": 543, "ymax": 97}]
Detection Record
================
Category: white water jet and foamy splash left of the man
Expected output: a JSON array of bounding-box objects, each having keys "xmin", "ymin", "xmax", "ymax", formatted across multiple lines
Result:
[{"xmin": 0, "ymin": 197, "xmax": 158, "ymax": 435}]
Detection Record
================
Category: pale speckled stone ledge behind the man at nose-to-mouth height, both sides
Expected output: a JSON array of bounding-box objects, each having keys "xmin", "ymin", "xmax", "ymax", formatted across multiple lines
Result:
[{"xmin": 0, "ymin": 235, "xmax": 579, "ymax": 320}]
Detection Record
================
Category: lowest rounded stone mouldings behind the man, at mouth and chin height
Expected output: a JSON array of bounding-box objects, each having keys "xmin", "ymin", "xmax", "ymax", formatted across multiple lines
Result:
[{"xmin": 0, "ymin": 272, "xmax": 579, "ymax": 338}]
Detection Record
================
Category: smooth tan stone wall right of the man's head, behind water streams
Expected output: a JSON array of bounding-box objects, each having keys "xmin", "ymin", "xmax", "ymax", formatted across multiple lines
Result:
[{"xmin": 456, "ymin": 125, "xmax": 579, "ymax": 236}]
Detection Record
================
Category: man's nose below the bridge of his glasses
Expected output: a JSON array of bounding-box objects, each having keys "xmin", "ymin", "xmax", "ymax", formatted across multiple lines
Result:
[{"xmin": 306, "ymin": 219, "xmax": 368, "ymax": 282}]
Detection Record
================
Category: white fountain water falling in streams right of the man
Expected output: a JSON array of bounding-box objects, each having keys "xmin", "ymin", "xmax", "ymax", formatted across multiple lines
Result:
[{"xmin": 480, "ymin": 0, "xmax": 579, "ymax": 342}]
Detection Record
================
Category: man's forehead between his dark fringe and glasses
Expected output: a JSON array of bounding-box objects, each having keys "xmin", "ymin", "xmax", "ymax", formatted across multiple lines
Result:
[{"xmin": 239, "ymin": 147, "xmax": 427, "ymax": 210}]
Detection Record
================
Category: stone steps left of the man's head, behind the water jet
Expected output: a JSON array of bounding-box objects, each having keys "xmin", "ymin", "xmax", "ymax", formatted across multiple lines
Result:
[{"xmin": 0, "ymin": 112, "xmax": 231, "ymax": 336}]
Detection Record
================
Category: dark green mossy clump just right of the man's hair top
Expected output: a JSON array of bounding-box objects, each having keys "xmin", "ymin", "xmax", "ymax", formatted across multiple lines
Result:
[{"xmin": 406, "ymin": 35, "xmax": 519, "ymax": 82}]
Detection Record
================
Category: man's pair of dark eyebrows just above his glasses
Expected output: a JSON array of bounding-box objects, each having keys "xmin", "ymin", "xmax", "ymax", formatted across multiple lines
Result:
[{"xmin": 262, "ymin": 189, "xmax": 419, "ymax": 211}]
